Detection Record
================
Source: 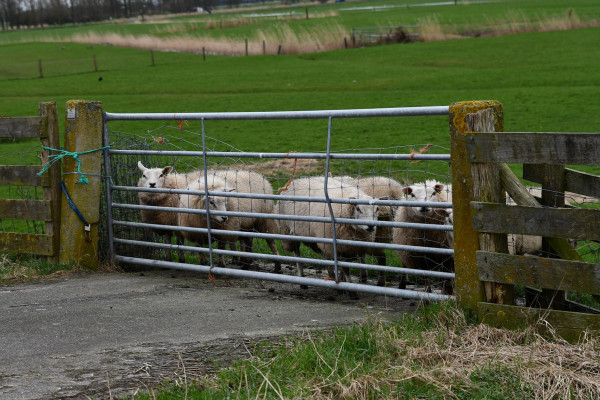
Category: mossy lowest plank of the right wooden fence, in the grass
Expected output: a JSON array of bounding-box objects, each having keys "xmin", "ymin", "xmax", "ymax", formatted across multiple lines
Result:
[{"xmin": 477, "ymin": 303, "xmax": 600, "ymax": 343}]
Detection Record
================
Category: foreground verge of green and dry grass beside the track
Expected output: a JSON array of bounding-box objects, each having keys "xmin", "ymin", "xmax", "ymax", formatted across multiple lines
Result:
[{"xmin": 132, "ymin": 303, "xmax": 600, "ymax": 400}]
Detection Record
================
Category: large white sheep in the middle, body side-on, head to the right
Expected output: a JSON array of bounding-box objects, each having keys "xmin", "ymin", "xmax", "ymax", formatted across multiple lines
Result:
[{"xmin": 278, "ymin": 177, "xmax": 379, "ymax": 287}]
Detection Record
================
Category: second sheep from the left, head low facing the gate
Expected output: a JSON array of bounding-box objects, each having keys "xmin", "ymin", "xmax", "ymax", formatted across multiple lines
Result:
[{"xmin": 178, "ymin": 175, "xmax": 236, "ymax": 267}]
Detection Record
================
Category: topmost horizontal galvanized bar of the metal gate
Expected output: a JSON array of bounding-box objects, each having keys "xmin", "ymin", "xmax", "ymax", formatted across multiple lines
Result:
[{"xmin": 104, "ymin": 106, "xmax": 450, "ymax": 121}]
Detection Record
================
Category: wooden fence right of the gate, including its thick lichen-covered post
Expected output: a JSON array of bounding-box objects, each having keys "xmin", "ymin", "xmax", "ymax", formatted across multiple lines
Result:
[{"xmin": 450, "ymin": 101, "xmax": 600, "ymax": 340}]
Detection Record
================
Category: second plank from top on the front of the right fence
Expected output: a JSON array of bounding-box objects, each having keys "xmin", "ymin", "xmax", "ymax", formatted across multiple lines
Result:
[{"xmin": 471, "ymin": 201, "xmax": 600, "ymax": 240}]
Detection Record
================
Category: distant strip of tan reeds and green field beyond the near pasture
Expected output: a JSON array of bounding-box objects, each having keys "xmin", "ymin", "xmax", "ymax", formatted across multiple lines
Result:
[{"xmin": 0, "ymin": 0, "xmax": 600, "ymax": 55}]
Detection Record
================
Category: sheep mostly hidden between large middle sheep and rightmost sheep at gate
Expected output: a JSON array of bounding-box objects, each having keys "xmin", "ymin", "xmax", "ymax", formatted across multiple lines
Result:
[{"xmin": 338, "ymin": 176, "xmax": 404, "ymax": 286}]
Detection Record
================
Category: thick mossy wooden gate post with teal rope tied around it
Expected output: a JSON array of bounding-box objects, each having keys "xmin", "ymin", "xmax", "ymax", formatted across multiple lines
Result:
[{"xmin": 60, "ymin": 100, "xmax": 103, "ymax": 268}]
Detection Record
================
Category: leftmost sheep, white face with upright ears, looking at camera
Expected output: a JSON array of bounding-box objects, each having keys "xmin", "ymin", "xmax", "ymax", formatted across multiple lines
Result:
[{"xmin": 138, "ymin": 161, "xmax": 197, "ymax": 263}]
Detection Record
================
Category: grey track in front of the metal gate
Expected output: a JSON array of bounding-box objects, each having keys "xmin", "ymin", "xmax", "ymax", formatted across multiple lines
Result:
[{"xmin": 0, "ymin": 271, "xmax": 416, "ymax": 400}]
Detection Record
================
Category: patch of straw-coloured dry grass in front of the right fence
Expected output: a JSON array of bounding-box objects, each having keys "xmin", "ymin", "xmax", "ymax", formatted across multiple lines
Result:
[{"xmin": 314, "ymin": 309, "xmax": 600, "ymax": 399}]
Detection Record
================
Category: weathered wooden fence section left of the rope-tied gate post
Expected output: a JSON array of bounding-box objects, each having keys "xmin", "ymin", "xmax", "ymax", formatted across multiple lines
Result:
[{"xmin": 0, "ymin": 102, "xmax": 61, "ymax": 261}]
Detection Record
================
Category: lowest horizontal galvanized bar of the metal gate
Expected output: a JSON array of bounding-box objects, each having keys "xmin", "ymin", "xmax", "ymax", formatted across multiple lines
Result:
[{"xmin": 116, "ymin": 256, "xmax": 453, "ymax": 301}]
